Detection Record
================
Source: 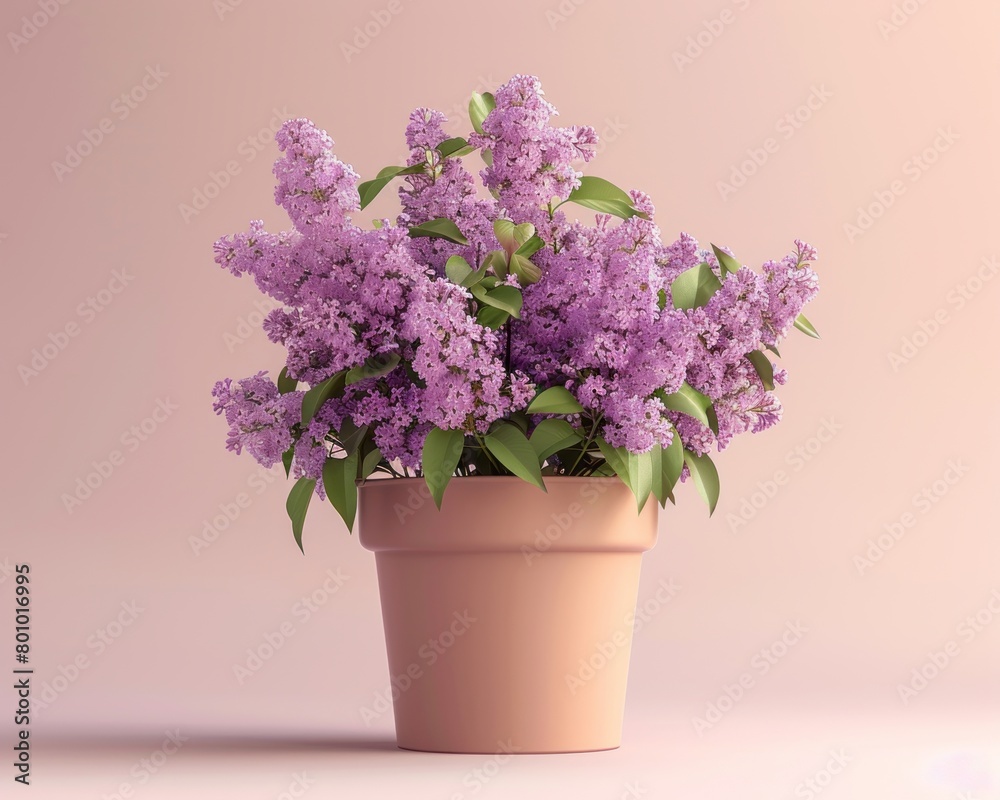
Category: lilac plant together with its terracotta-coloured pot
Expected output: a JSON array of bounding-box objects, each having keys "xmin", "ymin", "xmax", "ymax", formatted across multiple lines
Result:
[{"xmin": 213, "ymin": 75, "xmax": 817, "ymax": 752}]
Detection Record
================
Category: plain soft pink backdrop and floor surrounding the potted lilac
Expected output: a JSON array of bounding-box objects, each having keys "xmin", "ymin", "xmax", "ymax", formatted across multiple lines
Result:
[{"xmin": 0, "ymin": 0, "xmax": 1000, "ymax": 799}]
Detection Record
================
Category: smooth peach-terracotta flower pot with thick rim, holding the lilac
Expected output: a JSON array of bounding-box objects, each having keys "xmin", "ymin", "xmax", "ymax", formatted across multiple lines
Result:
[{"xmin": 358, "ymin": 477, "xmax": 657, "ymax": 753}]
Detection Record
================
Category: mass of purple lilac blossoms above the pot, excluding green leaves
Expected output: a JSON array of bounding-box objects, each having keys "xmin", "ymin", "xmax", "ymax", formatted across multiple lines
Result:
[{"xmin": 213, "ymin": 75, "xmax": 818, "ymax": 494}]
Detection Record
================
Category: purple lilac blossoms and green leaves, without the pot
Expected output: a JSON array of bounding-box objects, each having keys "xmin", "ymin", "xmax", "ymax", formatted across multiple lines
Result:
[{"xmin": 207, "ymin": 75, "xmax": 818, "ymax": 547}]
